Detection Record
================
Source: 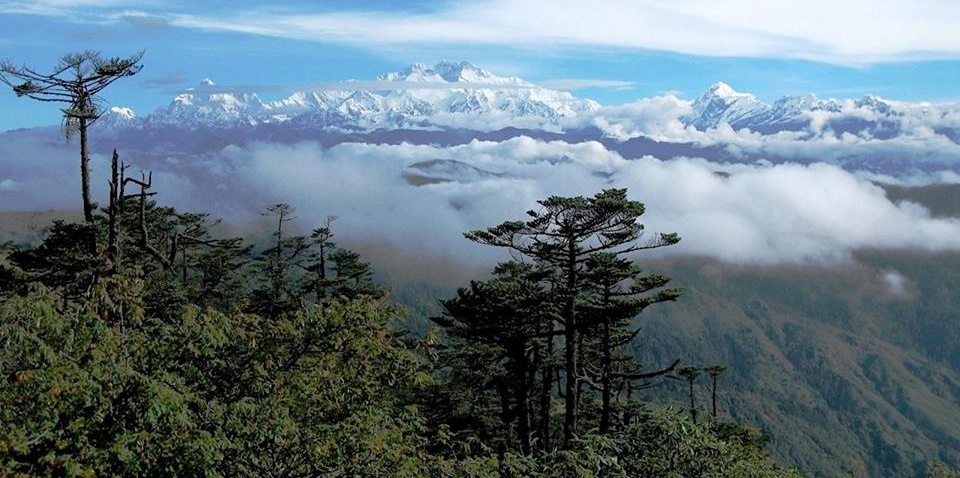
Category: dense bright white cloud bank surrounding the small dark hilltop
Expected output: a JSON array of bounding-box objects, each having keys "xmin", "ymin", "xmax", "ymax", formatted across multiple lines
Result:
[{"xmin": 176, "ymin": 138, "xmax": 960, "ymax": 263}]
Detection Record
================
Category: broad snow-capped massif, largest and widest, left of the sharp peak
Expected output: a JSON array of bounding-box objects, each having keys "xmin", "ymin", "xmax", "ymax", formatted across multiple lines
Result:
[{"xmin": 131, "ymin": 62, "xmax": 599, "ymax": 130}]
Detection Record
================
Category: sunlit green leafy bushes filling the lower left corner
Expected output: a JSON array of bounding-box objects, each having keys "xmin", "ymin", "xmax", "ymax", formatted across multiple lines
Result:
[{"xmin": 0, "ymin": 281, "xmax": 430, "ymax": 476}]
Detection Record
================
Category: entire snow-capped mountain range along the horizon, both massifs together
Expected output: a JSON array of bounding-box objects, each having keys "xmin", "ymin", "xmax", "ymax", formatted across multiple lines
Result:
[{"xmin": 100, "ymin": 62, "xmax": 960, "ymax": 148}]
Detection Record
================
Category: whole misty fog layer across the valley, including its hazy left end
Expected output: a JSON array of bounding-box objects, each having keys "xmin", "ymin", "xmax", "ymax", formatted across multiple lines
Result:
[{"xmin": 0, "ymin": 131, "xmax": 960, "ymax": 264}]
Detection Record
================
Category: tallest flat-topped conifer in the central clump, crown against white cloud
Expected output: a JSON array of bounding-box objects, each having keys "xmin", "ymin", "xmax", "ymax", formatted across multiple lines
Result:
[{"xmin": 465, "ymin": 189, "xmax": 680, "ymax": 445}]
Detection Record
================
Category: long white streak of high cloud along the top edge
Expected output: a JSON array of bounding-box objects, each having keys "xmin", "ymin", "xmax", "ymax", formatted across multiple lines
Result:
[{"xmin": 161, "ymin": 0, "xmax": 960, "ymax": 64}]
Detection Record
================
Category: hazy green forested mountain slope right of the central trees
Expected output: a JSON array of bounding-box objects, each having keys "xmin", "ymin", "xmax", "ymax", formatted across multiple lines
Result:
[{"xmin": 636, "ymin": 253, "xmax": 960, "ymax": 477}]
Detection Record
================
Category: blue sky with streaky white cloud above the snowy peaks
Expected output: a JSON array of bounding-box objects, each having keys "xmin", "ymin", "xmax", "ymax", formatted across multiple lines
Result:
[{"xmin": 0, "ymin": 0, "xmax": 960, "ymax": 130}]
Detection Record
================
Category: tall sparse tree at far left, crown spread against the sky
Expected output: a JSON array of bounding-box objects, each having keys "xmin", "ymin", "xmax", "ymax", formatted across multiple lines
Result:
[{"xmin": 0, "ymin": 51, "xmax": 143, "ymax": 223}]
